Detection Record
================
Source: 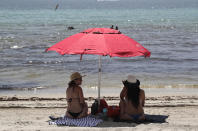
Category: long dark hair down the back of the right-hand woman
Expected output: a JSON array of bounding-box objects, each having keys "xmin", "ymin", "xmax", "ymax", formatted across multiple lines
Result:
[{"xmin": 123, "ymin": 80, "xmax": 140, "ymax": 108}]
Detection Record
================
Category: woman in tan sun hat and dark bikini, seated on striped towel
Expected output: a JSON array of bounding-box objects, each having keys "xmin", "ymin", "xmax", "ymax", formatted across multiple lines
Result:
[{"xmin": 66, "ymin": 72, "xmax": 88, "ymax": 118}]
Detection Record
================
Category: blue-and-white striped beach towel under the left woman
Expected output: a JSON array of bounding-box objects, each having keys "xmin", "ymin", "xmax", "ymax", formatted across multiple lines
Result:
[{"xmin": 49, "ymin": 115, "xmax": 103, "ymax": 127}]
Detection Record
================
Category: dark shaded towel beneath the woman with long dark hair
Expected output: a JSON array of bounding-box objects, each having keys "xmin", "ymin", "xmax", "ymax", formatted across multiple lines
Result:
[{"xmin": 98, "ymin": 114, "xmax": 169, "ymax": 127}]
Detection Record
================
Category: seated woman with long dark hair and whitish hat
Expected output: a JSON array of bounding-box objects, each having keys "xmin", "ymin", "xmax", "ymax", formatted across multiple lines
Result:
[{"xmin": 120, "ymin": 75, "xmax": 145, "ymax": 121}]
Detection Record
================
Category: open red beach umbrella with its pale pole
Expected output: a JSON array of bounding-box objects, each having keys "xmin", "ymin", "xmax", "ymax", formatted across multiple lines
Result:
[{"xmin": 46, "ymin": 28, "xmax": 151, "ymax": 99}]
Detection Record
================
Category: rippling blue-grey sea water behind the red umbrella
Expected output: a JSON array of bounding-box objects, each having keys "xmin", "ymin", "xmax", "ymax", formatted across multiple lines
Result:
[{"xmin": 0, "ymin": 0, "xmax": 198, "ymax": 94}]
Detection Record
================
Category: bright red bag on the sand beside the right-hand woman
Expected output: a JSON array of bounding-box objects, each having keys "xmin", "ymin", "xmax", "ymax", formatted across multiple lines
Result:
[{"xmin": 107, "ymin": 106, "xmax": 120, "ymax": 118}]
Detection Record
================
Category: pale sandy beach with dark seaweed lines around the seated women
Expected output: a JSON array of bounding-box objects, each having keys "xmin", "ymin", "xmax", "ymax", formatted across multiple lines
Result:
[{"xmin": 0, "ymin": 92, "xmax": 198, "ymax": 131}]
